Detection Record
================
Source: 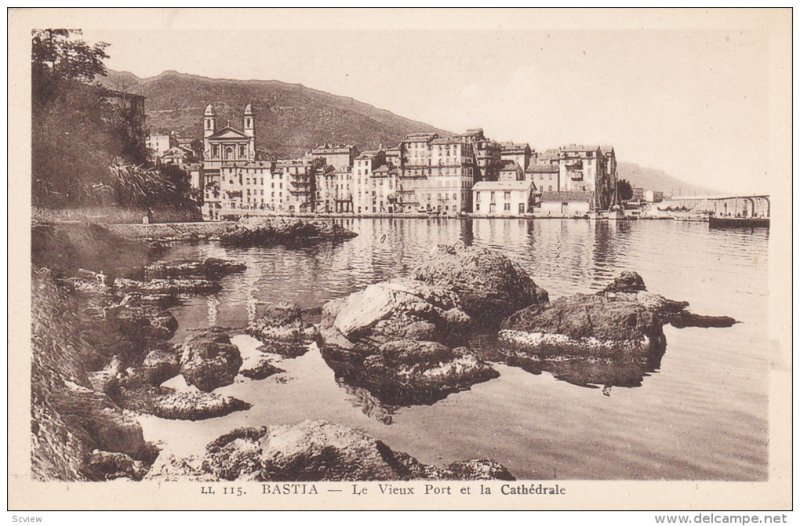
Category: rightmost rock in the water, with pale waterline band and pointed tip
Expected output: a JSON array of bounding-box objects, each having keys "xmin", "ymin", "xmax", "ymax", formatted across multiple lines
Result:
[{"xmin": 498, "ymin": 271, "xmax": 735, "ymax": 385}]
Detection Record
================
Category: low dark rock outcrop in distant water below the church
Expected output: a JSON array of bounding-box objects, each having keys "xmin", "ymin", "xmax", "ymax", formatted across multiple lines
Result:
[{"xmin": 219, "ymin": 217, "xmax": 357, "ymax": 246}]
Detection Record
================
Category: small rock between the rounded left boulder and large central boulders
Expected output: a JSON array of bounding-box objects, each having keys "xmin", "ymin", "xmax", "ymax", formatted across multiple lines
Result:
[{"xmin": 247, "ymin": 302, "xmax": 319, "ymax": 358}]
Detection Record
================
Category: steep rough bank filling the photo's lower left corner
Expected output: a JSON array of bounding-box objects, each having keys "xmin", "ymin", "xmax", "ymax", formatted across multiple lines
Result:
[{"xmin": 31, "ymin": 268, "xmax": 156, "ymax": 480}]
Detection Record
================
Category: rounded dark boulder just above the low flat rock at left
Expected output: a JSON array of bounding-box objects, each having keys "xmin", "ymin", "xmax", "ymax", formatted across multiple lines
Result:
[{"xmin": 181, "ymin": 327, "xmax": 242, "ymax": 392}]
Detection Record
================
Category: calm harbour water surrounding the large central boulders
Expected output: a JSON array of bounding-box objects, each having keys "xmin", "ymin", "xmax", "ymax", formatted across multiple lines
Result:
[{"xmin": 138, "ymin": 219, "xmax": 768, "ymax": 480}]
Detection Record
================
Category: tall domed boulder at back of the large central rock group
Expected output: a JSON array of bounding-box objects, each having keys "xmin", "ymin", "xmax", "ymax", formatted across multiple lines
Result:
[{"xmin": 414, "ymin": 244, "xmax": 548, "ymax": 326}]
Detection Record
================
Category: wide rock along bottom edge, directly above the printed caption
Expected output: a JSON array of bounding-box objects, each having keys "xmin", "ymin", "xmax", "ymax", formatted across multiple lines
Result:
[{"xmin": 197, "ymin": 420, "xmax": 513, "ymax": 481}]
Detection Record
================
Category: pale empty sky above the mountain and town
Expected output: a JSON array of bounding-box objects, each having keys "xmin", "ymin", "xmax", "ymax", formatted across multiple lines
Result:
[{"xmin": 78, "ymin": 12, "xmax": 792, "ymax": 193}]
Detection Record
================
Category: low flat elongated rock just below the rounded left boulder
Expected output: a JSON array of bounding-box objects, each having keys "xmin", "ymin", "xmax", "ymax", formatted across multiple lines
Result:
[{"xmin": 115, "ymin": 386, "xmax": 251, "ymax": 420}]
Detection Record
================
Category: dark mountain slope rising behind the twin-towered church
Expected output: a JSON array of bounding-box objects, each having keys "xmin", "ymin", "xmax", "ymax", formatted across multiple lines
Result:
[{"xmin": 100, "ymin": 70, "xmax": 453, "ymax": 157}]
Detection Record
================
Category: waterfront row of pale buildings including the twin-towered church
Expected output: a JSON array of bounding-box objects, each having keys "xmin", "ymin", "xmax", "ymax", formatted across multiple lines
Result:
[{"xmin": 170, "ymin": 104, "xmax": 617, "ymax": 219}]
